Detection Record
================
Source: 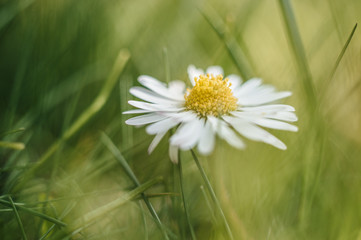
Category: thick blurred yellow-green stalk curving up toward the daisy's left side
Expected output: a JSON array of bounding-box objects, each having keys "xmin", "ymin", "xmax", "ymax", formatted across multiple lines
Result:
[{"xmin": 13, "ymin": 49, "xmax": 130, "ymax": 192}]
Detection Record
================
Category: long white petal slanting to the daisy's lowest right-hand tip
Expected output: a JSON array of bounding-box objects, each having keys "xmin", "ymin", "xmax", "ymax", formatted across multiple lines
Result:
[{"xmin": 223, "ymin": 116, "xmax": 287, "ymax": 150}]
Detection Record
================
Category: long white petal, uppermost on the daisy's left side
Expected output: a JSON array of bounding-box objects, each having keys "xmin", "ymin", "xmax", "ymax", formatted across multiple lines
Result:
[{"xmin": 138, "ymin": 75, "xmax": 184, "ymax": 101}]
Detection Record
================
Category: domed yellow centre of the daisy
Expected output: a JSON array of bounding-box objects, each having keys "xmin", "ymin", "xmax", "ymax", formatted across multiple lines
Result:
[{"xmin": 184, "ymin": 74, "xmax": 237, "ymax": 117}]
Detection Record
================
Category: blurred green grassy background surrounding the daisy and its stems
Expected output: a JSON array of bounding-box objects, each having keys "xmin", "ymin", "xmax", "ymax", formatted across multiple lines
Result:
[{"xmin": 0, "ymin": 0, "xmax": 361, "ymax": 240}]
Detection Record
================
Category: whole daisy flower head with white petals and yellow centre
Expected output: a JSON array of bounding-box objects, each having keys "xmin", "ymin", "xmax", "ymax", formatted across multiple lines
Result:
[{"xmin": 124, "ymin": 65, "xmax": 298, "ymax": 163}]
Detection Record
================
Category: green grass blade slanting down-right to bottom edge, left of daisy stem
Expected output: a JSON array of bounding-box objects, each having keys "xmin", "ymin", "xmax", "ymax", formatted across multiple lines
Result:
[{"xmin": 101, "ymin": 133, "xmax": 169, "ymax": 239}]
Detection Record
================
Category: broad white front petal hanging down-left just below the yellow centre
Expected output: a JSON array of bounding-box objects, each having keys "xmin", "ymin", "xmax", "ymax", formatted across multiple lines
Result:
[{"xmin": 170, "ymin": 119, "xmax": 203, "ymax": 150}]
